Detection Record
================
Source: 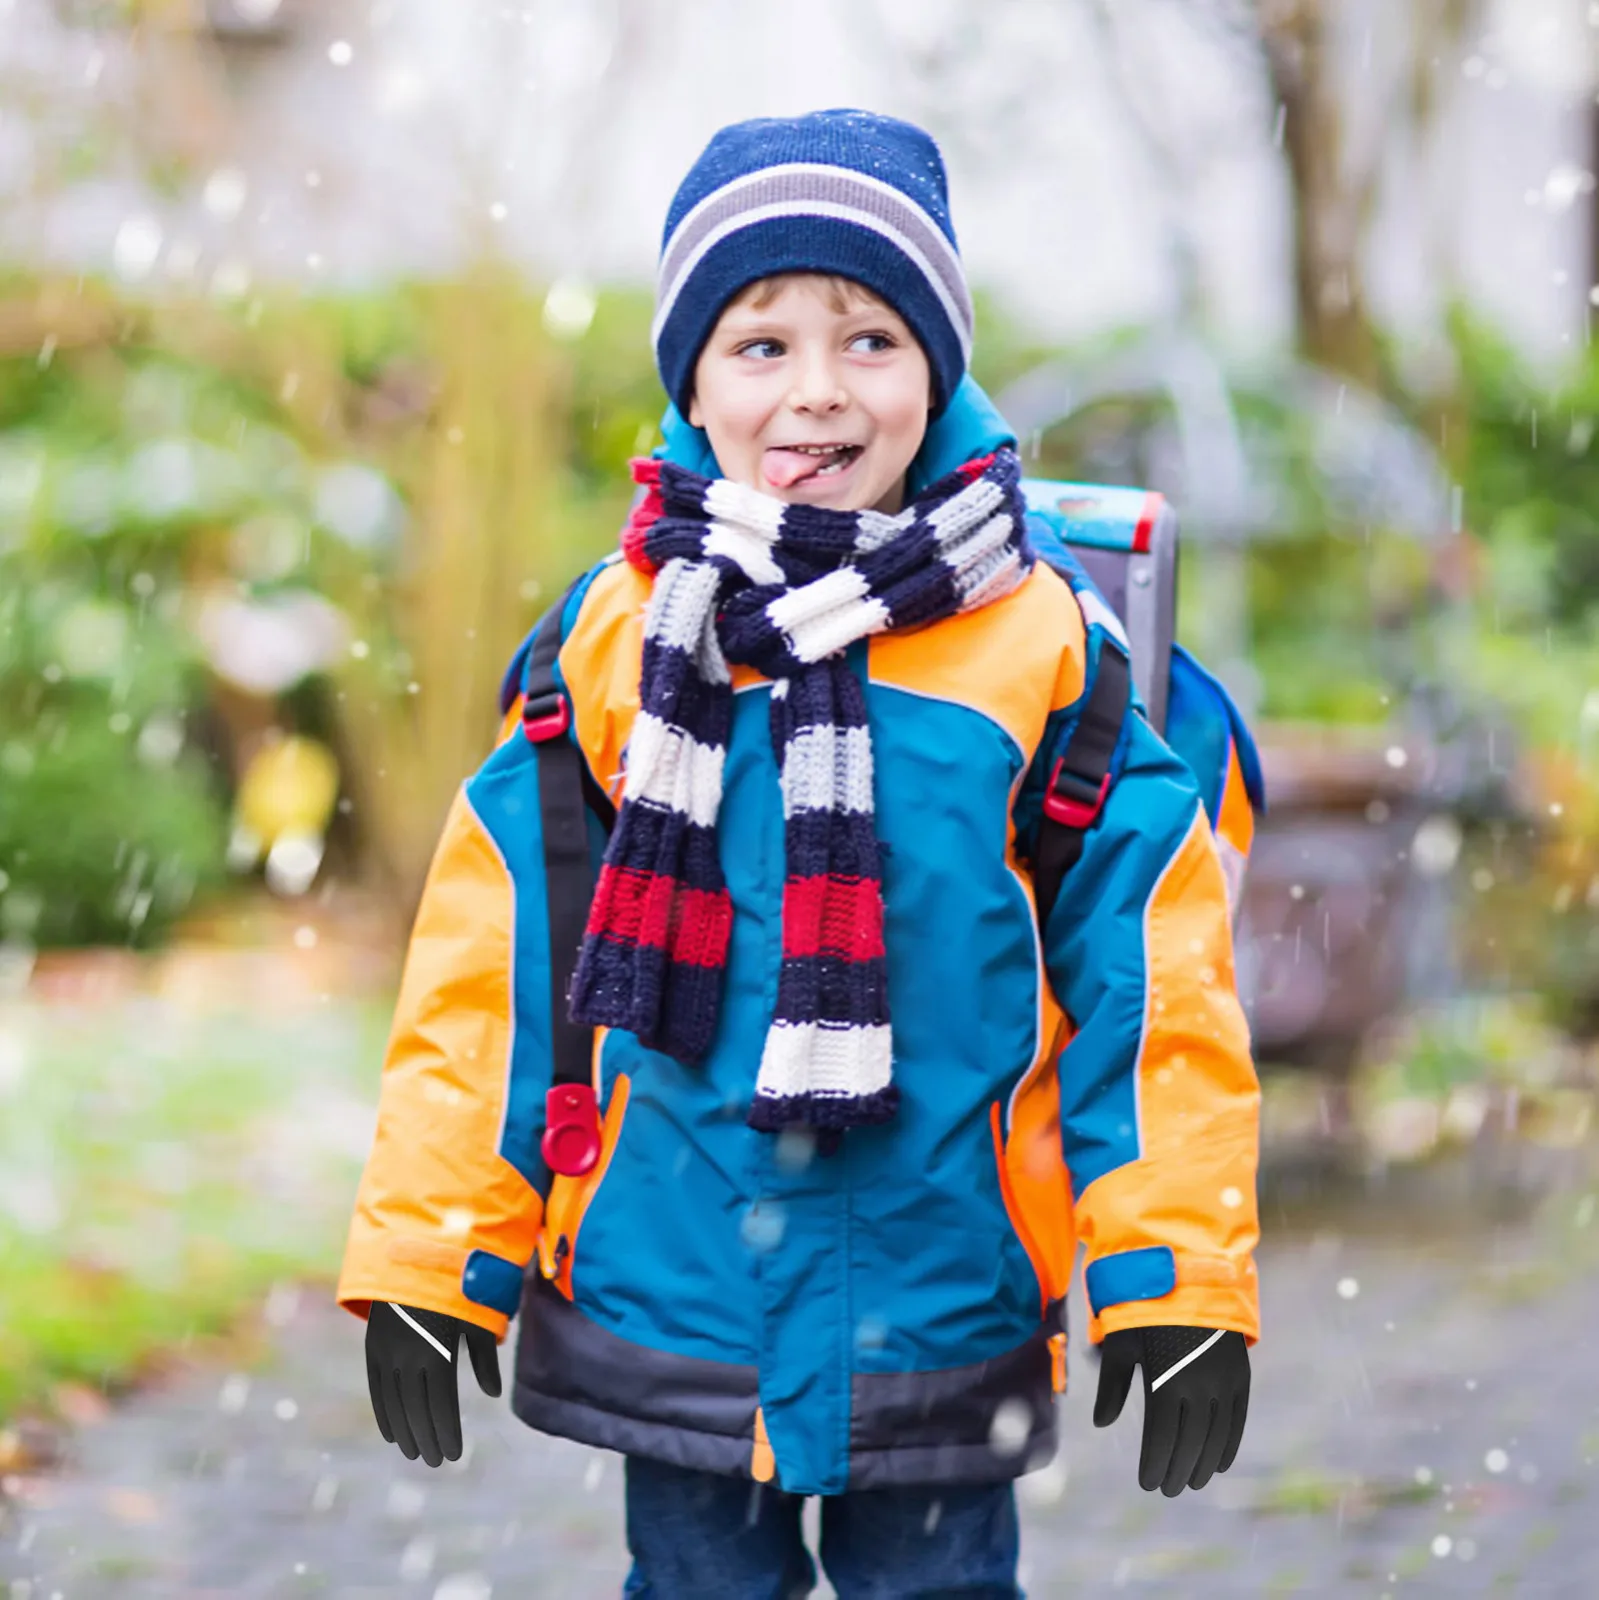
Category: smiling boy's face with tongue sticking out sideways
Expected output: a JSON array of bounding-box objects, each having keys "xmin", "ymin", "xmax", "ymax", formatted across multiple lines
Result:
[{"xmin": 688, "ymin": 274, "xmax": 932, "ymax": 512}]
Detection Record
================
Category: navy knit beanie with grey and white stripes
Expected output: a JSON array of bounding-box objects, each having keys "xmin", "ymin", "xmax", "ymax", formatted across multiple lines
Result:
[{"xmin": 651, "ymin": 110, "xmax": 972, "ymax": 416}]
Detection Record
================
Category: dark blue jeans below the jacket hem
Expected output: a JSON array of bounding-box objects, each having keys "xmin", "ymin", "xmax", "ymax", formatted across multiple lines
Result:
[{"xmin": 623, "ymin": 1456, "xmax": 1023, "ymax": 1600}]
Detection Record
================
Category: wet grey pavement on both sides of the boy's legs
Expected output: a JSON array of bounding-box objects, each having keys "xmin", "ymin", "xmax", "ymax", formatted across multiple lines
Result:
[{"xmin": 0, "ymin": 1171, "xmax": 1599, "ymax": 1600}]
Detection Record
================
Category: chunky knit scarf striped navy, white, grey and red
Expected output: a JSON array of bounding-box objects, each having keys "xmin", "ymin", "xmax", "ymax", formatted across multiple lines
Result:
[{"xmin": 570, "ymin": 450, "xmax": 1032, "ymax": 1142}]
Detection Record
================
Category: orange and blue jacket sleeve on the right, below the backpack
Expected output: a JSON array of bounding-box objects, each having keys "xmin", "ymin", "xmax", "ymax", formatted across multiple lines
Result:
[{"xmin": 1018, "ymin": 630, "xmax": 1260, "ymax": 1342}]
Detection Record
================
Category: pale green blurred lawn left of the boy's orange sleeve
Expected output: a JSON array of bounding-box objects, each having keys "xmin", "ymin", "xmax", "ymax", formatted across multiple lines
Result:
[{"xmin": 0, "ymin": 1002, "xmax": 389, "ymax": 1421}]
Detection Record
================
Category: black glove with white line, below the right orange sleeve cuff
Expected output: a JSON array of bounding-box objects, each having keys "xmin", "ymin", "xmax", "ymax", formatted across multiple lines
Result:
[{"xmin": 1093, "ymin": 1328, "xmax": 1248, "ymax": 1494}]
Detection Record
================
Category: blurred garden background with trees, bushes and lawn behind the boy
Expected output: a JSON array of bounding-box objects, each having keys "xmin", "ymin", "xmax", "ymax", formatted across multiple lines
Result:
[{"xmin": 0, "ymin": 0, "xmax": 1599, "ymax": 1600}]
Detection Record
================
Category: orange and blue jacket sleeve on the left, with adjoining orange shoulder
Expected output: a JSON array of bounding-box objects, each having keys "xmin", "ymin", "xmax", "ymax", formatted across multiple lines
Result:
[{"xmin": 336, "ymin": 563, "xmax": 637, "ymax": 1338}]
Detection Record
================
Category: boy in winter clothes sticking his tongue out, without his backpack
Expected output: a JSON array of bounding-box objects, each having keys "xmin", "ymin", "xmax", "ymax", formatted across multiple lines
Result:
[{"xmin": 338, "ymin": 112, "xmax": 1258, "ymax": 1600}]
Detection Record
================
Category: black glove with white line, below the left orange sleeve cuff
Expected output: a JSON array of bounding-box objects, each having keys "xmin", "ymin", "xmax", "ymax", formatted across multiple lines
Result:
[{"xmin": 367, "ymin": 1301, "xmax": 499, "ymax": 1467}]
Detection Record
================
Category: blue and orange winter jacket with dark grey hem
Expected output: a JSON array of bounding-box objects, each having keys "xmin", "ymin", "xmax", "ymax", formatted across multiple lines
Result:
[{"xmin": 338, "ymin": 384, "xmax": 1260, "ymax": 1494}]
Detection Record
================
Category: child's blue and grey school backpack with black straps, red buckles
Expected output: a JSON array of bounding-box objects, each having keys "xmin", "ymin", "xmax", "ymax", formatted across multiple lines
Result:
[{"xmin": 499, "ymin": 478, "xmax": 1266, "ymax": 1176}]
